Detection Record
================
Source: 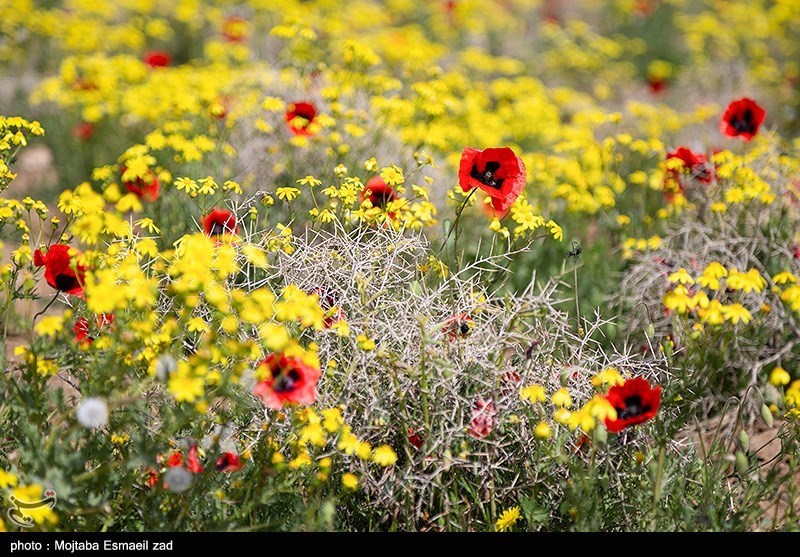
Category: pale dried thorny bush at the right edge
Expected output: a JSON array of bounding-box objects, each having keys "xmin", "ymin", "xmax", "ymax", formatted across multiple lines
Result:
[{"xmin": 612, "ymin": 135, "xmax": 800, "ymax": 410}]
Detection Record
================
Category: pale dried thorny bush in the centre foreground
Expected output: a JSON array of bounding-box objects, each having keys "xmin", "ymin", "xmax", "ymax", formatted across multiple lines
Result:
[{"xmin": 268, "ymin": 219, "xmax": 667, "ymax": 524}]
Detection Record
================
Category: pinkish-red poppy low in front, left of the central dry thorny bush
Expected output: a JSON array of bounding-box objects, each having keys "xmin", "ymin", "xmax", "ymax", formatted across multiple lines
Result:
[{"xmin": 253, "ymin": 354, "xmax": 320, "ymax": 410}]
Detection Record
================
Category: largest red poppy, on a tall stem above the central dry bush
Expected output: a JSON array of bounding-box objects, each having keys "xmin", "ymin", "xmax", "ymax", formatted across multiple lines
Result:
[{"xmin": 458, "ymin": 147, "xmax": 526, "ymax": 211}]
